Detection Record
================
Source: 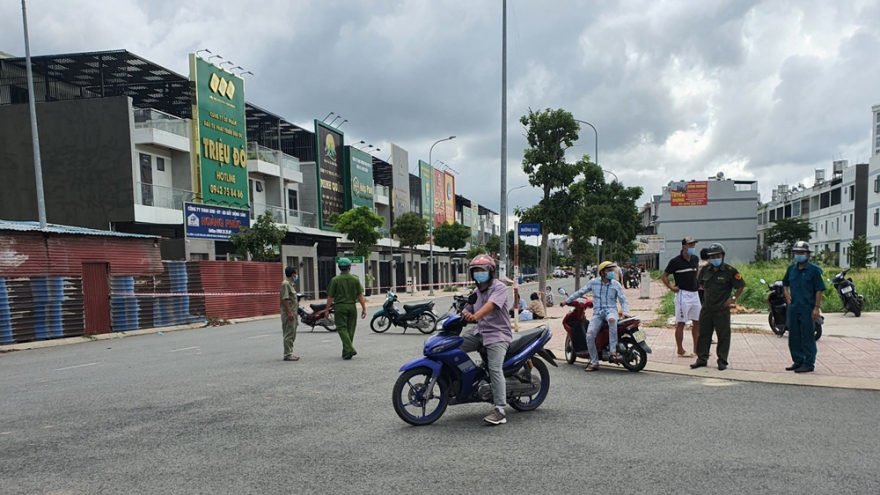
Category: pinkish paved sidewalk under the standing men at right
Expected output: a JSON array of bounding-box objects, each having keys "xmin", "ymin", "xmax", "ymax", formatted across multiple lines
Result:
[{"xmin": 529, "ymin": 283, "xmax": 880, "ymax": 390}]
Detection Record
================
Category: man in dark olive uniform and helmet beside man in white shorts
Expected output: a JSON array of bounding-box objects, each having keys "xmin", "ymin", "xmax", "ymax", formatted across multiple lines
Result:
[{"xmin": 691, "ymin": 242, "xmax": 746, "ymax": 370}]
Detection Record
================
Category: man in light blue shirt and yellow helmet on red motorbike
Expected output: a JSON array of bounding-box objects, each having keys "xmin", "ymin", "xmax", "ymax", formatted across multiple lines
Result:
[{"xmin": 559, "ymin": 261, "xmax": 629, "ymax": 371}]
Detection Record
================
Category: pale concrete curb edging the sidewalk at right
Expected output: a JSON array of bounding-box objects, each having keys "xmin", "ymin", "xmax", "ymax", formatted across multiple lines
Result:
[{"xmin": 551, "ymin": 349, "xmax": 880, "ymax": 391}]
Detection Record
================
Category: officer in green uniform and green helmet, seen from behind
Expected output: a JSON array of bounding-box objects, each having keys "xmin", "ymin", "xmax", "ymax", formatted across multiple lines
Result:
[{"xmin": 325, "ymin": 258, "xmax": 367, "ymax": 359}]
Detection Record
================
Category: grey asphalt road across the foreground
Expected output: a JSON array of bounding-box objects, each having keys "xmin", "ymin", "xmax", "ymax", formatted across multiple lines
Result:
[{"xmin": 0, "ymin": 284, "xmax": 880, "ymax": 495}]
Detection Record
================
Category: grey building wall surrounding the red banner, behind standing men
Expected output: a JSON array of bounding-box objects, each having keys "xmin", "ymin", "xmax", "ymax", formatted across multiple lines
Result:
[{"xmin": 656, "ymin": 180, "xmax": 758, "ymax": 269}]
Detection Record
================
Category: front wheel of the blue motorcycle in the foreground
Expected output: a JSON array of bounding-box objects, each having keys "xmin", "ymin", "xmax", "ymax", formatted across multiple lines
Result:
[{"xmin": 391, "ymin": 367, "xmax": 449, "ymax": 426}]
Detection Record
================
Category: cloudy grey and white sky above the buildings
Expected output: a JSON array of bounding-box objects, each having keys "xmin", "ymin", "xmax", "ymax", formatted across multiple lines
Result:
[{"xmin": 0, "ymin": 0, "xmax": 880, "ymax": 221}]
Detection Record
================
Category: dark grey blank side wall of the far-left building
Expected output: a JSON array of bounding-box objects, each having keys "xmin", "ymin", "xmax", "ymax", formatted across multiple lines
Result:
[{"xmin": 0, "ymin": 97, "xmax": 134, "ymax": 229}]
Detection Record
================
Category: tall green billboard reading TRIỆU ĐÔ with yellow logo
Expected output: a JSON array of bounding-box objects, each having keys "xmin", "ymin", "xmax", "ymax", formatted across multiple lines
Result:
[{"xmin": 189, "ymin": 54, "xmax": 250, "ymax": 209}]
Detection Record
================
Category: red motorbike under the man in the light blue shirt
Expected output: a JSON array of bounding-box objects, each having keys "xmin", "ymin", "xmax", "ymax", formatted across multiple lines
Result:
[{"xmin": 559, "ymin": 289, "xmax": 652, "ymax": 371}]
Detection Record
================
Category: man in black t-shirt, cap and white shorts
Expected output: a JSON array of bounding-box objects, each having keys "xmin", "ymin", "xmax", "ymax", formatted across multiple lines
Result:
[{"xmin": 662, "ymin": 237, "xmax": 702, "ymax": 357}]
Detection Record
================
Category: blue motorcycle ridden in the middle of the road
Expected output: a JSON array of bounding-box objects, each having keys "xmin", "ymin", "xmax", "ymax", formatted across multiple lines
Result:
[{"xmin": 392, "ymin": 316, "xmax": 557, "ymax": 426}]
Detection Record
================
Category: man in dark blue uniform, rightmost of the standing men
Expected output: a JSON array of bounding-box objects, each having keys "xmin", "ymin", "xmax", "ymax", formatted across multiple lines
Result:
[{"xmin": 782, "ymin": 241, "xmax": 825, "ymax": 373}]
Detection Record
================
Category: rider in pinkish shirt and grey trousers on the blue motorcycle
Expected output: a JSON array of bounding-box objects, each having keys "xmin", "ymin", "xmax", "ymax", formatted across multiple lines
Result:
[{"xmin": 461, "ymin": 254, "xmax": 513, "ymax": 425}]
